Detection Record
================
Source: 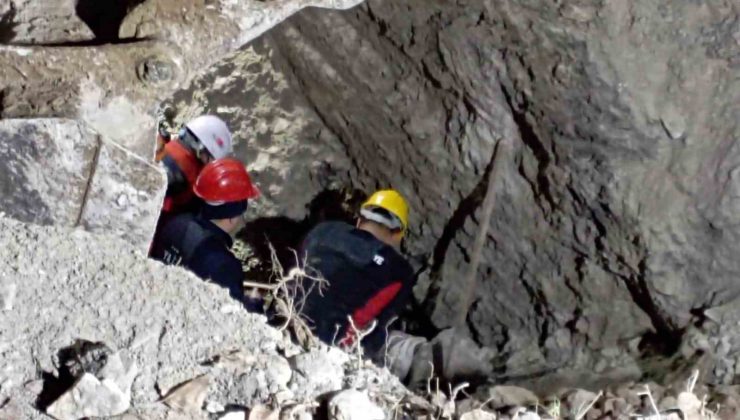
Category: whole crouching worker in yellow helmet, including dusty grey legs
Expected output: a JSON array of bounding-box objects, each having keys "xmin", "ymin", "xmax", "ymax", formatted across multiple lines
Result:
[{"xmin": 294, "ymin": 190, "xmax": 492, "ymax": 388}]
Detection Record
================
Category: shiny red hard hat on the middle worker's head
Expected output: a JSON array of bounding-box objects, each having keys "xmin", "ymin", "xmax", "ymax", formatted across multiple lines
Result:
[{"xmin": 193, "ymin": 158, "xmax": 260, "ymax": 203}]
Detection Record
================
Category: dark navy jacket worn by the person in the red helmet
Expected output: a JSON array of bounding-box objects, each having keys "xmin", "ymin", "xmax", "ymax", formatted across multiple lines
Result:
[{"xmin": 151, "ymin": 214, "xmax": 244, "ymax": 302}]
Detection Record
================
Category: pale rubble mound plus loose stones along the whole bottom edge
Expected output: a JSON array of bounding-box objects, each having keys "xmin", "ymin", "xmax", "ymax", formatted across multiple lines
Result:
[{"xmin": 0, "ymin": 217, "xmax": 740, "ymax": 420}]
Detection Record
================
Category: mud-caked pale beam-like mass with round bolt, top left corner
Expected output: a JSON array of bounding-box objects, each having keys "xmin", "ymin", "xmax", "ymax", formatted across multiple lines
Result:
[{"xmin": 0, "ymin": 0, "xmax": 368, "ymax": 159}]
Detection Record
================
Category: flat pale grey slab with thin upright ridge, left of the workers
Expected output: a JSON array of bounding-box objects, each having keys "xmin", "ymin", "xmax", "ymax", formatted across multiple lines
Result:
[{"xmin": 0, "ymin": 118, "xmax": 166, "ymax": 251}]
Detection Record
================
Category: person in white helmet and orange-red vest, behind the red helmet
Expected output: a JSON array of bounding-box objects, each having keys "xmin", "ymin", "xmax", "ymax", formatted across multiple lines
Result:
[{"xmin": 156, "ymin": 115, "xmax": 232, "ymax": 215}]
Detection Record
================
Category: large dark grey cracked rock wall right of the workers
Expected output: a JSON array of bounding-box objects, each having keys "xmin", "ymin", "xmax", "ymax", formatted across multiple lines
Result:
[{"xmin": 178, "ymin": 0, "xmax": 740, "ymax": 386}]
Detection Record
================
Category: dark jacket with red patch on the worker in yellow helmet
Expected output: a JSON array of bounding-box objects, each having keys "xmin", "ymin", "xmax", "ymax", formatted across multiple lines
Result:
[{"xmin": 303, "ymin": 222, "xmax": 414, "ymax": 355}]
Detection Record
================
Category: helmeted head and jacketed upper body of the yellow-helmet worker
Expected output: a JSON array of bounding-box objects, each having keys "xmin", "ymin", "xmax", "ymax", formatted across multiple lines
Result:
[{"xmin": 303, "ymin": 190, "xmax": 414, "ymax": 354}]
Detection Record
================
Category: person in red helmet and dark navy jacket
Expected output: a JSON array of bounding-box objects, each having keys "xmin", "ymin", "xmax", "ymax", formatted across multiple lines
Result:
[{"xmin": 152, "ymin": 158, "xmax": 259, "ymax": 303}]
